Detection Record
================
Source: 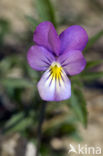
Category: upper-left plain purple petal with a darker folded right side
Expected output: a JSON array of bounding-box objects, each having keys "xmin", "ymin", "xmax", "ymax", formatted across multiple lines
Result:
[{"xmin": 33, "ymin": 21, "xmax": 60, "ymax": 56}]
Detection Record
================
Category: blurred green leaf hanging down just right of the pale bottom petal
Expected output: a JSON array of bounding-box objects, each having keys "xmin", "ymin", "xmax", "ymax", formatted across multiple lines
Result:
[{"xmin": 70, "ymin": 89, "xmax": 87, "ymax": 127}]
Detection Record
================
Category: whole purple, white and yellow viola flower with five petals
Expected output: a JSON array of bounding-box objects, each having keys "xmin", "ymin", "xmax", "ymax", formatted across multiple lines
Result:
[{"xmin": 27, "ymin": 21, "xmax": 88, "ymax": 101}]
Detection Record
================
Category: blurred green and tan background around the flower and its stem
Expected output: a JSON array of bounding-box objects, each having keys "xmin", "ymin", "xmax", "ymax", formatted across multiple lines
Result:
[{"xmin": 0, "ymin": 0, "xmax": 103, "ymax": 156}]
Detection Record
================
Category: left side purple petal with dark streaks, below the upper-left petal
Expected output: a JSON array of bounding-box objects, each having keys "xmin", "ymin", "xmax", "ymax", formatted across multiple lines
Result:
[{"xmin": 27, "ymin": 46, "xmax": 55, "ymax": 71}]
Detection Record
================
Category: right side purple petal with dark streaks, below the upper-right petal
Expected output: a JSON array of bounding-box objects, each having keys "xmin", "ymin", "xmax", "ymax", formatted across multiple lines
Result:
[{"xmin": 58, "ymin": 50, "xmax": 86, "ymax": 75}]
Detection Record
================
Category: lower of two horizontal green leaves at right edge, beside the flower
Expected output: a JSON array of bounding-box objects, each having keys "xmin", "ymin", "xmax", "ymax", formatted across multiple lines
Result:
[{"xmin": 79, "ymin": 71, "xmax": 103, "ymax": 81}]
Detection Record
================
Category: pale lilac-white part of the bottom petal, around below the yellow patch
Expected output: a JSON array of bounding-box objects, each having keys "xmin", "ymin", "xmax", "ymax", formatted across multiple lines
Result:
[{"xmin": 37, "ymin": 70, "xmax": 71, "ymax": 101}]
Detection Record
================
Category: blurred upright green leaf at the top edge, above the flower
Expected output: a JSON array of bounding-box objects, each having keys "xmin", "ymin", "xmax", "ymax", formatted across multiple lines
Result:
[{"xmin": 36, "ymin": 0, "xmax": 56, "ymax": 26}]
